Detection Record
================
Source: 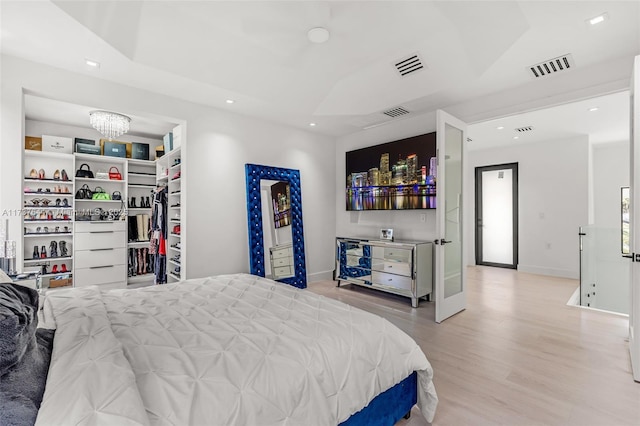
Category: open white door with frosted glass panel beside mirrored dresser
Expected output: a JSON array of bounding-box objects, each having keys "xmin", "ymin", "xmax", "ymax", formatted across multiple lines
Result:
[{"xmin": 435, "ymin": 110, "xmax": 467, "ymax": 322}]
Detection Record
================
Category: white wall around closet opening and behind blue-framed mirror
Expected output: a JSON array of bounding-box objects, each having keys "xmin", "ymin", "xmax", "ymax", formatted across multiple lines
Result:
[{"xmin": 0, "ymin": 56, "xmax": 336, "ymax": 279}]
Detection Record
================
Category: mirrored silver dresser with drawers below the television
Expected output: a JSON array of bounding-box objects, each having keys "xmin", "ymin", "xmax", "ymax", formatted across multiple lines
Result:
[{"xmin": 336, "ymin": 238, "xmax": 433, "ymax": 308}]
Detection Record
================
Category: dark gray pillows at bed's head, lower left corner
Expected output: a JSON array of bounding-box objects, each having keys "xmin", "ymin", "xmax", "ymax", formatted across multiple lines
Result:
[{"xmin": 0, "ymin": 283, "xmax": 55, "ymax": 425}]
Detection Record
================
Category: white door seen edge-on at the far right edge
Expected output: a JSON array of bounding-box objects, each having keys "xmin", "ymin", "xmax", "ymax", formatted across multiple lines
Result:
[{"xmin": 629, "ymin": 56, "xmax": 640, "ymax": 382}]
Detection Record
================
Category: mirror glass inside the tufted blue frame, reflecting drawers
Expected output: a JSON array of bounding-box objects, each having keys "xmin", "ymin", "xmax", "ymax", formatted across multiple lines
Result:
[{"xmin": 260, "ymin": 179, "xmax": 295, "ymax": 280}]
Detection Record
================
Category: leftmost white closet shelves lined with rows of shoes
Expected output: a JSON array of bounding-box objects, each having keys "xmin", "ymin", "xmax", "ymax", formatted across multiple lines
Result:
[{"xmin": 22, "ymin": 150, "xmax": 75, "ymax": 287}]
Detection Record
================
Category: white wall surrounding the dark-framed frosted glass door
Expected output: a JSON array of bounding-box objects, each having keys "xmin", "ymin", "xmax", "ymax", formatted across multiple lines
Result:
[{"xmin": 465, "ymin": 136, "xmax": 589, "ymax": 278}]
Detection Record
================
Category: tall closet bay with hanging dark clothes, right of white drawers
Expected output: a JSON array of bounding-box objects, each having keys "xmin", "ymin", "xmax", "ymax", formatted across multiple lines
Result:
[{"xmin": 127, "ymin": 159, "xmax": 156, "ymax": 284}]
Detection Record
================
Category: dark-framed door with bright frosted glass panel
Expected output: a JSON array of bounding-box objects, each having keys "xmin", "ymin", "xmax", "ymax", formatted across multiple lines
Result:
[{"xmin": 475, "ymin": 163, "xmax": 518, "ymax": 269}]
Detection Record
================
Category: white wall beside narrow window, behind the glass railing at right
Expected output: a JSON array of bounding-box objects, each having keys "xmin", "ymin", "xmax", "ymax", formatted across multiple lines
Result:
[{"xmin": 587, "ymin": 141, "xmax": 631, "ymax": 313}]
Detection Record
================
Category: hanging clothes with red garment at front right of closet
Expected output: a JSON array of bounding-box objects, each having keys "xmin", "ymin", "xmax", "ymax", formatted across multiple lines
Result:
[{"xmin": 149, "ymin": 186, "xmax": 169, "ymax": 284}]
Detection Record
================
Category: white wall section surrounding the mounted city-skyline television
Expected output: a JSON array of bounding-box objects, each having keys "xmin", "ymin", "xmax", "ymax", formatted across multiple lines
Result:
[{"xmin": 335, "ymin": 112, "xmax": 436, "ymax": 241}]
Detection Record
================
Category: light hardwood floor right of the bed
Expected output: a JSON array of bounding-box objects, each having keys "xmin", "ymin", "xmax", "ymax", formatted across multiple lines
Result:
[{"xmin": 309, "ymin": 266, "xmax": 640, "ymax": 426}]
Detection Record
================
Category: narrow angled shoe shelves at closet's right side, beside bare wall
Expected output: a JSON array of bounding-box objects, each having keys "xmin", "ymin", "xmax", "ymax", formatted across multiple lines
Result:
[{"xmin": 156, "ymin": 147, "xmax": 186, "ymax": 282}]
